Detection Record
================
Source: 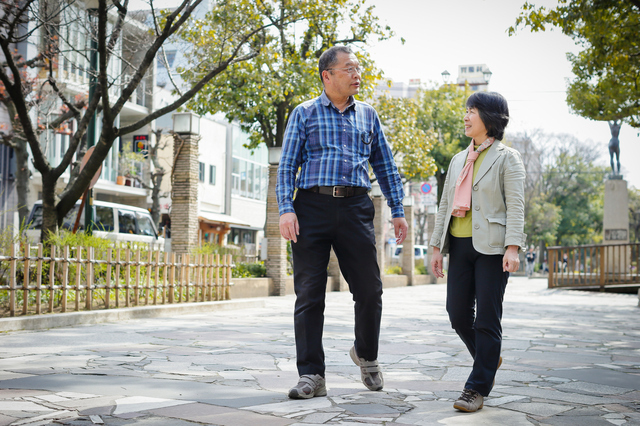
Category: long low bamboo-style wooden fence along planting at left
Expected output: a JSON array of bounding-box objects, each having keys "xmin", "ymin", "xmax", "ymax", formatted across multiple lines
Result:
[{"xmin": 0, "ymin": 244, "xmax": 234, "ymax": 317}]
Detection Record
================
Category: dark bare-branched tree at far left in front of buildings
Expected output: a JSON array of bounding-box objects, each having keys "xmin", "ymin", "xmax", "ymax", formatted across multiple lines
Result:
[{"xmin": 0, "ymin": 0, "xmax": 279, "ymax": 238}]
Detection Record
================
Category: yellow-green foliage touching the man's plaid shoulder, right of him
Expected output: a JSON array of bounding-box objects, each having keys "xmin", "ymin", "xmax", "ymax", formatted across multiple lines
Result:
[{"xmin": 375, "ymin": 96, "xmax": 437, "ymax": 180}]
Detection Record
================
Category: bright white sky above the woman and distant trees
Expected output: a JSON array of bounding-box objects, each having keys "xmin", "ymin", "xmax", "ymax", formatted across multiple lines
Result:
[{"xmin": 367, "ymin": 0, "xmax": 640, "ymax": 188}]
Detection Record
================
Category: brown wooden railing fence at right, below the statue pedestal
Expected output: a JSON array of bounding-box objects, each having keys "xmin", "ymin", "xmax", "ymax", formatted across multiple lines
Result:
[{"xmin": 547, "ymin": 243, "xmax": 640, "ymax": 290}]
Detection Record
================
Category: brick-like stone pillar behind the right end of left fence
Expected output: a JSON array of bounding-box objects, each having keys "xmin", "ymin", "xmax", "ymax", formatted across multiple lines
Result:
[{"xmin": 171, "ymin": 134, "xmax": 200, "ymax": 253}]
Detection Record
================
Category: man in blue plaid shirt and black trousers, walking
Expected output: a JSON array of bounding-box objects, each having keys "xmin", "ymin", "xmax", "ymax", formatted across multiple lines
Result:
[{"xmin": 276, "ymin": 46, "xmax": 407, "ymax": 399}]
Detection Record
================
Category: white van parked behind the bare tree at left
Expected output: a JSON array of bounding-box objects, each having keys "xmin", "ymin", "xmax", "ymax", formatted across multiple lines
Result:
[{"xmin": 26, "ymin": 200, "xmax": 164, "ymax": 250}]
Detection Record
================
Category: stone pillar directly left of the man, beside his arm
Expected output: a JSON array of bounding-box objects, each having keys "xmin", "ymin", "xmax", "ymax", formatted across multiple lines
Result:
[{"xmin": 263, "ymin": 147, "xmax": 287, "ymax": 296}]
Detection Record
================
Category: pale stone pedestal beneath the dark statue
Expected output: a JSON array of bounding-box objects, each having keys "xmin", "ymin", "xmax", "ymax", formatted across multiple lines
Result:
[{"xmin": 602, "ymin": 179, "xmax": 631, "ymax": 274}]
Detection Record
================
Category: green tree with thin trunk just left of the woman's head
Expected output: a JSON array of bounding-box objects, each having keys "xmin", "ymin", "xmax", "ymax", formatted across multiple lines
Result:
[{"xmin": 417, "ymin": 84, "xmax": 471, "ymax": 203}]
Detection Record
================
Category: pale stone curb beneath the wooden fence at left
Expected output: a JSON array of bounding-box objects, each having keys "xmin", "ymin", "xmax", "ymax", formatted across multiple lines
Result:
[{"xmin": 0, "ymin": 299, "xmax": 265, "ymax": 332}]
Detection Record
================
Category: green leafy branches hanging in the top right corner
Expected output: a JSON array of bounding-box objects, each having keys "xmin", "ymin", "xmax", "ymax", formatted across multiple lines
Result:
[{"xmin": 509, "ymin": 0, "xmax": 640, "ymax": 127}]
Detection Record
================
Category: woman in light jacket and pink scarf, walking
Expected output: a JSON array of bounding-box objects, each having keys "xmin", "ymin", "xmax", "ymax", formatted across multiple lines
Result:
[{"xmin": 430, "ymin": 92, "xmax": 526, "ymax": 412}]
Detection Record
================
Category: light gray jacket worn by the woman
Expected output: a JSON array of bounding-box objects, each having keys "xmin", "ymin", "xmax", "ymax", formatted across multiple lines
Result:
[{"xmin": 430, "ymin": 141, "xmax": 527, "ymax": 254}]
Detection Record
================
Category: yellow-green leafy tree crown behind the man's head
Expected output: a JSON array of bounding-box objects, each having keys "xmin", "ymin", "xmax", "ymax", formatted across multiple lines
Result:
[{"xmin": 181, "ymin": 0, "xmax": 393, "ymax": 147}]
